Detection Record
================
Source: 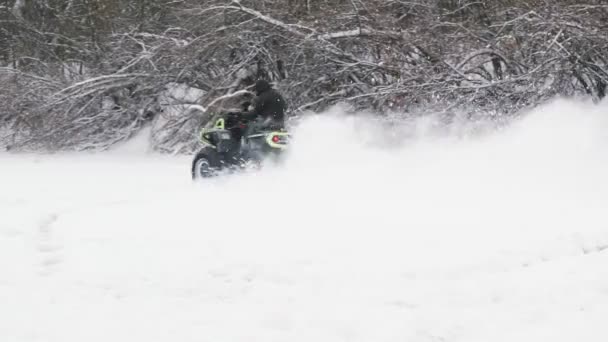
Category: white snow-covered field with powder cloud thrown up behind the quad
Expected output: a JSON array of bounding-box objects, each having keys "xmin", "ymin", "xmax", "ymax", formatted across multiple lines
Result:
[{"xmin": 0, "ymin": 97, "xmax": 608, "ymax": 342}]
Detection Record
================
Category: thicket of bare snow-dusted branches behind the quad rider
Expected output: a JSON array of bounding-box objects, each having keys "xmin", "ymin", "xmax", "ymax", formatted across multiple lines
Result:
[{"xmin": 0, "ymin": 0, "xmax": 608, "ymax": 152}]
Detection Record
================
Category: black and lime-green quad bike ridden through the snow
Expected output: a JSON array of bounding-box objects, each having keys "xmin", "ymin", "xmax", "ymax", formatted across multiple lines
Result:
[{"xmin": 192, "ymin": 112, "xmax": 290, "ymax": 180}]
